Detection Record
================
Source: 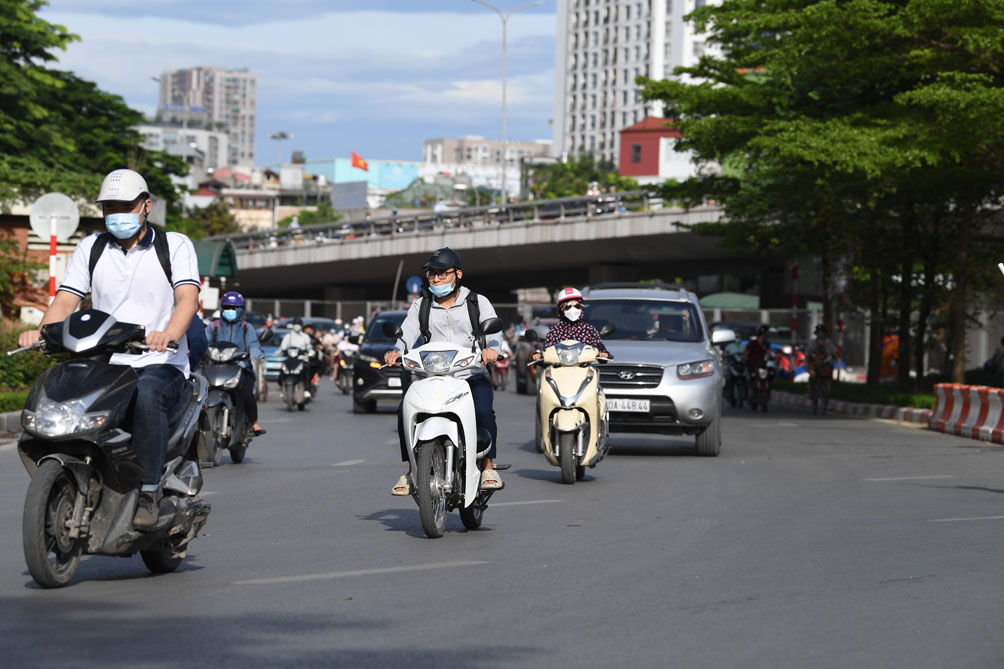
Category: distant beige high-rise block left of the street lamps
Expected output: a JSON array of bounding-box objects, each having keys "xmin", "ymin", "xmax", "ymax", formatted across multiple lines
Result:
[{"xmin": 158, "ymin": 65, "xmax": 258, "ymax": 167}]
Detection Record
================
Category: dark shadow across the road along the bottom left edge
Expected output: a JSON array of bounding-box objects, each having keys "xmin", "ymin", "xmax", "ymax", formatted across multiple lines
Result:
[{"xmin": 0, "ymin": 598, "xmax": 541, "ymax": 668}]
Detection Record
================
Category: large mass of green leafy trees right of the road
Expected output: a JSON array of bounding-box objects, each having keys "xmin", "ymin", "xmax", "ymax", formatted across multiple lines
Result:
[{"xmin": 641, "ymin": 0, "xmax": 1004, "ymax": 382}]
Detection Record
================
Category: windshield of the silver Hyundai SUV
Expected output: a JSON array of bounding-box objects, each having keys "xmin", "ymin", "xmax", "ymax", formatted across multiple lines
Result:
[{"xmin": 584, "ymin": 299, "xmax": 704, "ymax": 342}]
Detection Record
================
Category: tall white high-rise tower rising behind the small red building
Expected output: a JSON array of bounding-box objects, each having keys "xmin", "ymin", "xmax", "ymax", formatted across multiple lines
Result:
[{"xmin": 553, "ymin": 0, "xmax": 719, "ymax": 163}]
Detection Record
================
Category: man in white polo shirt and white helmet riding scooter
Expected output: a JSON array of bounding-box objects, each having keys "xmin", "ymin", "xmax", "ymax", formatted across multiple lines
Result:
[{"xmin": 20, "ymin": 170, "xmax": 200, "ymax": 527}]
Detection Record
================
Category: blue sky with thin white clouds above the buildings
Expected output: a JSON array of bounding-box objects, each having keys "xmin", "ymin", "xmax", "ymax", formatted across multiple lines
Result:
[{"xmin": 40, "ymin": 0, "xmax": 557, "ymax": 164}]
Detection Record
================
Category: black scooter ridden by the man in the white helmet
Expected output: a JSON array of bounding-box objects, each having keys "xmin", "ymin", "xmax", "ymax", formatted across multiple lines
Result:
[{"xmin": 7, "ymin": 309, "xmax": 210, "ymax": 588}]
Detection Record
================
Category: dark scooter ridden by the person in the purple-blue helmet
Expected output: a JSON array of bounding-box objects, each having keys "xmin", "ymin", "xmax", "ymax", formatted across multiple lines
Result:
[{"xmin": 199, "ymin": 328, "xmax": 271, "ymax": 467}]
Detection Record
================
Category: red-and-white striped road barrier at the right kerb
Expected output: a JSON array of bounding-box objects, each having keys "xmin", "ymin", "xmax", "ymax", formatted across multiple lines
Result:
[{"xmin": 931, "ymin": 384, "xmax": 1004, "ymax": 444}]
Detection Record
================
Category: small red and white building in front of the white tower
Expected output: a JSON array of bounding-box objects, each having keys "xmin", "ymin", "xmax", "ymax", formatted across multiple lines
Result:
[{"xmin": 617, "ymin": 117, "xmax": 697, "ymax": 184}]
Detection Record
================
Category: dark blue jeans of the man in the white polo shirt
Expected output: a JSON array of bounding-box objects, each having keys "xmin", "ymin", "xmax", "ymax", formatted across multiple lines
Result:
[{"xmin": 133, "ymin": 365, "xmax": 191, "ymax": 490}]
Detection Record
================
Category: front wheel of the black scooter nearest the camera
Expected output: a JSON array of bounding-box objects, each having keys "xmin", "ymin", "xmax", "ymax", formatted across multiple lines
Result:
[{"xmin": 21, "ymin": 460, "xmax": 83, "ymax": 588}]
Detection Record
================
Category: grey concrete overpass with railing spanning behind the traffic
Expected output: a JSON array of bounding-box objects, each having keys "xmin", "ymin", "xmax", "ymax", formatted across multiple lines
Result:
[{"xmin": 209, "ymin": 193, "xmax": 765, "ymax": 300}]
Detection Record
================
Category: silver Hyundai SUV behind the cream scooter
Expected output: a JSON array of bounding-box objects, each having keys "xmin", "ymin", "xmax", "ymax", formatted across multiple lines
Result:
[{"xmin": 582, "ymin": 283, "xmax": 735, "ymax": 456}]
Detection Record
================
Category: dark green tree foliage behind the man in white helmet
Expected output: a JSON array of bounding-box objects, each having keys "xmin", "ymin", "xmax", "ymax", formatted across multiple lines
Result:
[{"xmin": 0, "ymin": 0, "xmax": 188, "ymax": 213}]
